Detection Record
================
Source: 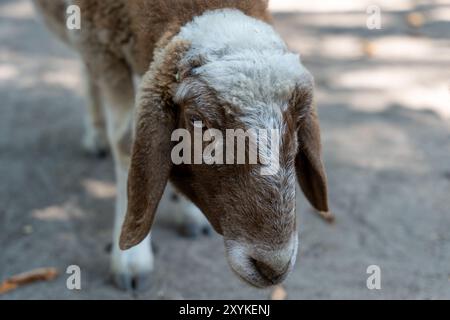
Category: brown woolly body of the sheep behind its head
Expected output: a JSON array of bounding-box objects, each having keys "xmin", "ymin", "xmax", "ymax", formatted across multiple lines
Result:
[{"xmin": 33, "ymin": 0, "xmax": 270, "ymax": 75}]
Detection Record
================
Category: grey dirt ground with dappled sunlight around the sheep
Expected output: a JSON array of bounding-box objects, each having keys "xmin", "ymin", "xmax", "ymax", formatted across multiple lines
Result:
[{"xmin": 0, "ymin": 0, "xmax": 450, "ymax": 299}]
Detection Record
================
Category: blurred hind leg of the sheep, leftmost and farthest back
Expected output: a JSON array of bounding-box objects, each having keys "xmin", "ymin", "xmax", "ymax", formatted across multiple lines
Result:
[{"xmin": 82, "ymin": 68, "xmax": 109, "ymax": 157}]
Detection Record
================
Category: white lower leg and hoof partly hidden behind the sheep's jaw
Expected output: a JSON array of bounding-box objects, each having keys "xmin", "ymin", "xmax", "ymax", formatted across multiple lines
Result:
[{"xmin": 161, "ymin": 184, "xmax": 212, "ymax": 238}]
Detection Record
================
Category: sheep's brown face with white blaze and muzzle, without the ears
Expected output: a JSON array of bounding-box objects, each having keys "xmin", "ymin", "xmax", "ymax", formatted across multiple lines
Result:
[{"xmin": 172, "ymin": 75, "xmax": 312, "ymax": 287}]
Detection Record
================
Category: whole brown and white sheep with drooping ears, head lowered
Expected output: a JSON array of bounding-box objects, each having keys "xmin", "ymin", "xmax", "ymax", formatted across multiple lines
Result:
[{"xmin": 33, "ymin": 0, "xmax": 332, "ymax": 289}]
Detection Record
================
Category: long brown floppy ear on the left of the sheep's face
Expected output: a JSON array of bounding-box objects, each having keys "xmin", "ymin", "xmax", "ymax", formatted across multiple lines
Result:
[{"xmin": 120, "ymin": 40, "xmax": 189, "ymax": 250}]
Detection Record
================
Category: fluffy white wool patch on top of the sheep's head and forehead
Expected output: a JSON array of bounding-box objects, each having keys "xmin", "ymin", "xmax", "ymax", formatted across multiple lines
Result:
[{"xmin": 178, "ymin": 9, "xmax": 307, "ymax": 129}]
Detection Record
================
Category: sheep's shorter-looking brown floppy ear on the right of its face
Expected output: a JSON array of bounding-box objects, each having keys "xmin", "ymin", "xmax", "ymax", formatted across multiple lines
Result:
[{"xmin": 295, "ymin": 105, "xmax": 329, "ymax": 212}]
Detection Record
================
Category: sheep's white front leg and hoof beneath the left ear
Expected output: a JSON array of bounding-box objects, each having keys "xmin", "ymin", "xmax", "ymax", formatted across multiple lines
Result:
[{"xmin": 100, "ymin": 67, "xmax": 153, "ymax": 290}]
